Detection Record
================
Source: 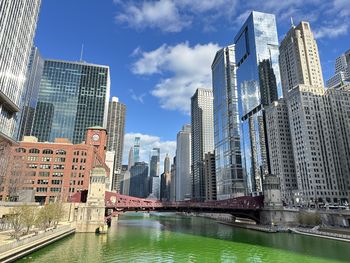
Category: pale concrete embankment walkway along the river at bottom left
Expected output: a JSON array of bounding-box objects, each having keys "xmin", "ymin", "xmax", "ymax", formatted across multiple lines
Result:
[{"xmin": 0, "ymin": 225, "xmax": 75, "ymax": 263}]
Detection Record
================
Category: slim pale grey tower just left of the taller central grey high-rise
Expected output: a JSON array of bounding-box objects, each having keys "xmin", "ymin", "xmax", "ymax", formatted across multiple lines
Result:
[{"xmin": 175, "ymin": 124, "xmax": 192, "ymax": 201}]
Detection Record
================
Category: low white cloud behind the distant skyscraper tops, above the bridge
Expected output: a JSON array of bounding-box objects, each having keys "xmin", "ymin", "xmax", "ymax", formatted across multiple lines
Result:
[{"xmin": 123, "ymin": 133, "xmax": 176, "ymax": 172}]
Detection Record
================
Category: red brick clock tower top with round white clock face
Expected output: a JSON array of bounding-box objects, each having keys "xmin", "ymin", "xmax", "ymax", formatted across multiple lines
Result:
[{"xmin": 85, "ymin": 126, "xmax": 107, "ymax": 161}]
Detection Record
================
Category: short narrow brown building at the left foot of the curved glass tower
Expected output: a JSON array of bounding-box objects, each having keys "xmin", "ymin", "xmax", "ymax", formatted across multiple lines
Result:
[{"xmin": 204, "ymin": 153, "xmax": 216, "ymax": 200}]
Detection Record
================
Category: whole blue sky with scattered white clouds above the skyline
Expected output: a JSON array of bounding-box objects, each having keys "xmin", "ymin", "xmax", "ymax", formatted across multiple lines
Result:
[{"xmin": 34, "ymin": 0, "xmax": 350, "ymax": 168}]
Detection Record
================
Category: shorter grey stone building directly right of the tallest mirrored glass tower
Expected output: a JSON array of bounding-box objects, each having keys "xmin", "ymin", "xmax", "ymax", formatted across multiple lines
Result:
[{"xmin": 265, "ymin": 98, "xmax": 298, "ymax": 205}]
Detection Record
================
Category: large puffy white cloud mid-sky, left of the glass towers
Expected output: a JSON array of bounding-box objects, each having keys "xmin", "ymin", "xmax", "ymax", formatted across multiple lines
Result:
[{"xmin": 132, "ymin": 42, "xmax": 220, "ymax": 113}]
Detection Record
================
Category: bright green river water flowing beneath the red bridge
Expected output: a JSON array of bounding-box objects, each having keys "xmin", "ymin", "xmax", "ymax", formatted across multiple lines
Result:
[{"xmin": 20, "ymin": 216, "xmax": 350, "ymax": 263}]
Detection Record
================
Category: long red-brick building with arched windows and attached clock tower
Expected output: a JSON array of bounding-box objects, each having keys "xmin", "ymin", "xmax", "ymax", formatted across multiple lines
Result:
[{"xmin": 0, "ymin": 127, "xmax": 109, "ymax": 203}]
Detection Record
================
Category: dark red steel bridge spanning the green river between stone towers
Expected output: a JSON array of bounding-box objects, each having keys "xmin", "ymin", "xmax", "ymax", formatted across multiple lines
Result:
[{"xmin": 105, "ymin": 192, "xmax": 264, "ymax": 222}]
